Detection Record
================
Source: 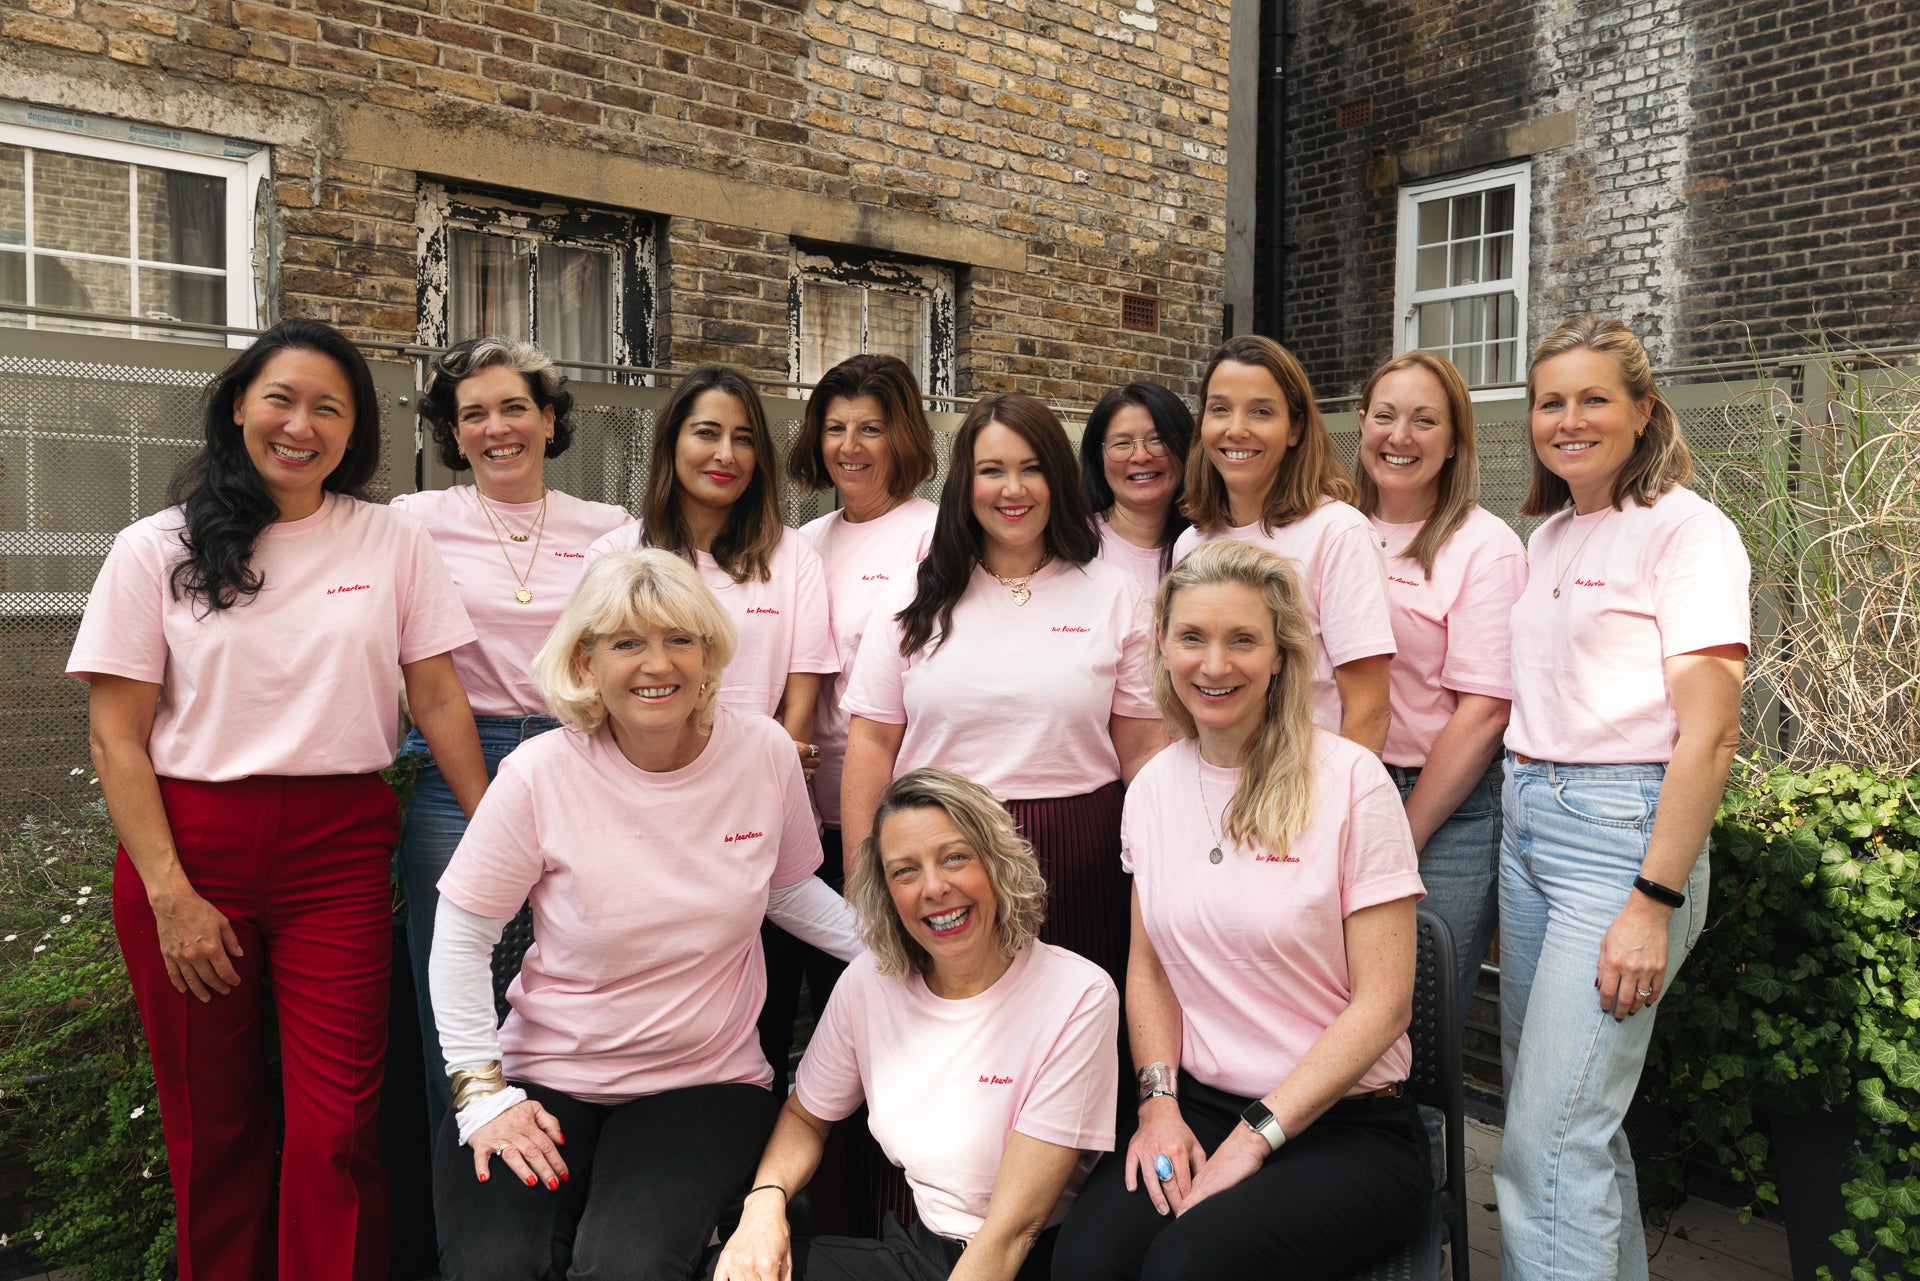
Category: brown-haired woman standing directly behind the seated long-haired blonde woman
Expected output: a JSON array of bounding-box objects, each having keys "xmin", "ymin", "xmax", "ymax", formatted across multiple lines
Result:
[{"xmin": 1173, "ymin": 334, "xmax": 1394, "ymax": 753}]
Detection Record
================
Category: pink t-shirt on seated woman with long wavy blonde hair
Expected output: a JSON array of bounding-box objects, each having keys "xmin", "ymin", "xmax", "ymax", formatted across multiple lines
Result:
[{"xmin": 1119, "ymin": 730, "xmax": 1427, "ymax": 1099}]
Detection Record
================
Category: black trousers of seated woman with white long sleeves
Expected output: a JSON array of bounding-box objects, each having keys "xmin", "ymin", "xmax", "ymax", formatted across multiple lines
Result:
[{"xmin": 434, "ymin": 1081, "xmax": 778, "ymax": 1281}]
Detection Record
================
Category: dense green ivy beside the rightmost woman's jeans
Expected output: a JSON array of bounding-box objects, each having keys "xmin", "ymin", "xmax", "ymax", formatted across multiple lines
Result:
[{"xmin": 1651, "ymin": 764, "xmax": 1920, "ymax": 1281}]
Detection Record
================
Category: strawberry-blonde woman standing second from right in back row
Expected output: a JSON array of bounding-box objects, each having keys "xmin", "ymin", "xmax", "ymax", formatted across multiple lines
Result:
[{"xmin": 1354, "ymin": 351, "xmax": 1526, "ymax": 1027}]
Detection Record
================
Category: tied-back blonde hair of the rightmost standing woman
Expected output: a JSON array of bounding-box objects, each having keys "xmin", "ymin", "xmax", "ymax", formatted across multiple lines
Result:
[{"xmin": 1521, "ymin": 315, "xmax": 1693, "ymax": 517}]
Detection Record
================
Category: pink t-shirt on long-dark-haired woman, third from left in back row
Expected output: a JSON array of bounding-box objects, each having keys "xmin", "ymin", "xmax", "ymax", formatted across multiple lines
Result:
[{"xmin": 588, "ymin": 520, "xmax": 839, "ymax": 722}]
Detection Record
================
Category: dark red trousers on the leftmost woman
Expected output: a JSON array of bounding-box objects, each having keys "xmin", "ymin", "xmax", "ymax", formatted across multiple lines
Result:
[{"xmin": 113, "ymin": 774, "xmax": 399, "ymax": 1281}]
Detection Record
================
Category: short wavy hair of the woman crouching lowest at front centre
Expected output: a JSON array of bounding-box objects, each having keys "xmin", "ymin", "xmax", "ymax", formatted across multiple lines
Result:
[{"xmin": 847, "ymin": 766, "xmax": 1046, "ymax": 976}]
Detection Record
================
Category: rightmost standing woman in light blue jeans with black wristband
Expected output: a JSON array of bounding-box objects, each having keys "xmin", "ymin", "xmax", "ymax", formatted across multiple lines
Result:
[{"xmin": 1494, "ymin": 317, "xmax": 1751, "ymax": 1281}]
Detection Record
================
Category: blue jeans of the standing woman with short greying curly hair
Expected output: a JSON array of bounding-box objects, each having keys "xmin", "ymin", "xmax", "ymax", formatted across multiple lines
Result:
[{"xmin": 394, "ymin": 716, "xmax": 561, "ymax": 1139}]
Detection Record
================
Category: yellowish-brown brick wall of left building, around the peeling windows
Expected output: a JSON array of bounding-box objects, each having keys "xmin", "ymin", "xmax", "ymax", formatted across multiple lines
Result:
[{"xmin": 0, "ymin": 0, "xmax": 1227, "ymax": 403}]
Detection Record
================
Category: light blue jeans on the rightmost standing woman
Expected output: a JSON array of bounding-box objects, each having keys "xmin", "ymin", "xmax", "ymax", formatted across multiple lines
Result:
[{"xmin": 1494, "ymin": 757, "xmax": 1707, "ymax": 1281}]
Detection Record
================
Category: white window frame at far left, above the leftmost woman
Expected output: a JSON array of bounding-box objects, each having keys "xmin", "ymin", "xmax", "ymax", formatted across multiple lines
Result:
[{"xmin": 0, "ymin": 121, "xmax": 269, "ymax": 348}]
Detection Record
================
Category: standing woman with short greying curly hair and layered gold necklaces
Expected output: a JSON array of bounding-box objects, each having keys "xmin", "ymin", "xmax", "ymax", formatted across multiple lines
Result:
[{"xmin": 394, "ymin": 338, "xmax": 634, "ymax": 1133}]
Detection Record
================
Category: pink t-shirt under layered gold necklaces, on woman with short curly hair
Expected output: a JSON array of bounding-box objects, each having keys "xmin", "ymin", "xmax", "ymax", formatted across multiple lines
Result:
[{"xmin": 394, "ymin": 484, "xmax": 634, "ymax": 716}]
